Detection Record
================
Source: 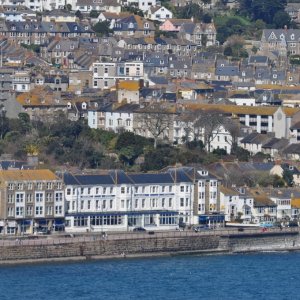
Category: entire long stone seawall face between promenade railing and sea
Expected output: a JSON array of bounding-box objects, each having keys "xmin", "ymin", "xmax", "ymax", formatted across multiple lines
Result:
[{"xmin": 0, "ymin": 232, "xmax": 300, "ymax": 264}]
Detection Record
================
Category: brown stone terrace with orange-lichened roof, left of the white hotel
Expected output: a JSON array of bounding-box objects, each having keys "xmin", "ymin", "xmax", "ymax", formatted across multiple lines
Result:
[{"xmin": 0, "ymin": 170, "xmax": 65, "ymax": 234}]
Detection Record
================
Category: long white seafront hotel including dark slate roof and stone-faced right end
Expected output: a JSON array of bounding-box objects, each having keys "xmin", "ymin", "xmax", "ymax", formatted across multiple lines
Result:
[{"xmin": 64, "ymin": 167, "xmax": 223, "ymax": 232}]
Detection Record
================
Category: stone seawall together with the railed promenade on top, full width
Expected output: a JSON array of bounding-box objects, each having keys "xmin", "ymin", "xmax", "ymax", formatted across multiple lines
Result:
[{"xmin": 0, "ymin": 228, "xmax": 300, "ymax": 264}]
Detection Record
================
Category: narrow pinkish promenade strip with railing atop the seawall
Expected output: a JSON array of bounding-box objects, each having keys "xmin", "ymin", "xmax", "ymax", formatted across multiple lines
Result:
[{"xmin": 0, "ymin": 227, "xmax": 299, "ymax": 247}]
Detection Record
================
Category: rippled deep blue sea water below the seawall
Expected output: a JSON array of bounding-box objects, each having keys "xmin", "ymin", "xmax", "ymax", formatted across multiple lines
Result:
[{"xmin": 0, "ymin": 253, "xmax": 300, "ymax": 300}]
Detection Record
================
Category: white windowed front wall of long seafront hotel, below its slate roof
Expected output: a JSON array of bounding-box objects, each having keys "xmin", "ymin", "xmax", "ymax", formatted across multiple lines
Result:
[{"xmin": 65, "ymin": 173, "xmax": 193, "ymax": 232}]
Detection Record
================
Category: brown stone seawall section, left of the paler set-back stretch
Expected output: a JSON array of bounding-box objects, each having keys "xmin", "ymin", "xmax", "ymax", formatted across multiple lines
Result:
[{"xmin": 0, "ymin": 236, "xmax": 219, "ymax": 261}]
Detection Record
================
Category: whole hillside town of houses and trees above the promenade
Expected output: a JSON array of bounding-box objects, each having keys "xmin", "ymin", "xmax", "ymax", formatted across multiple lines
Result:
[{"xmin": 0, "ymin": 0, "xmax": 300, "ymax": 234}]
